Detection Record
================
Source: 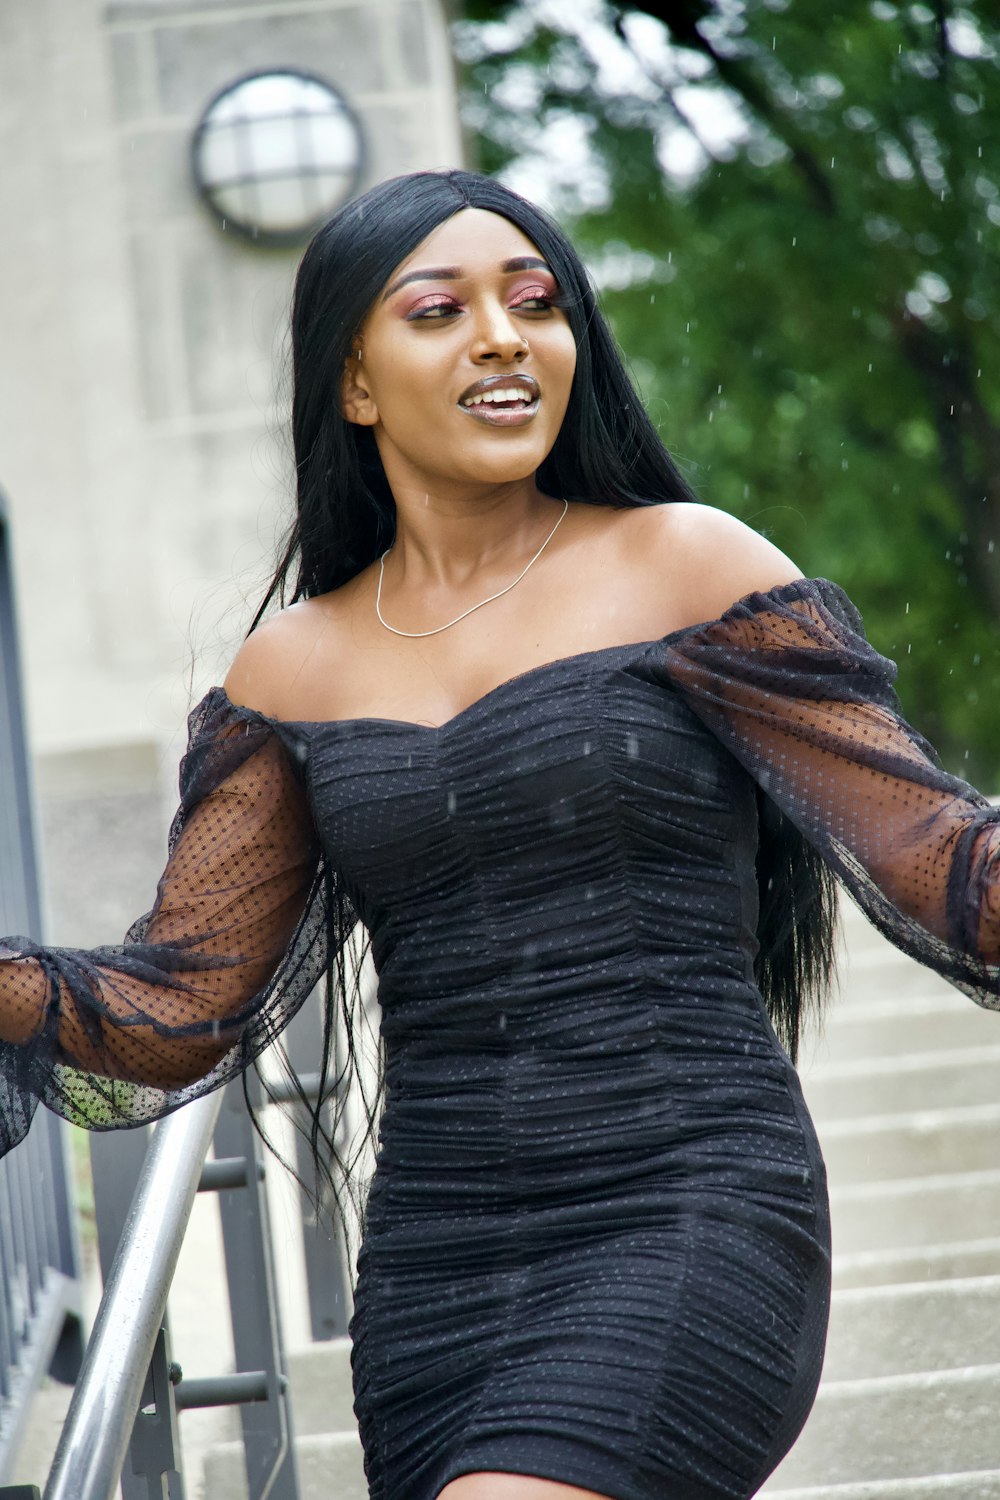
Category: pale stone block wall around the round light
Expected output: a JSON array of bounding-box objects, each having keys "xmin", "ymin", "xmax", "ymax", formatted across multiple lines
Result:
[{"xmin": 0, "ymin": 0, "xmax": 462, "ymax": 942}]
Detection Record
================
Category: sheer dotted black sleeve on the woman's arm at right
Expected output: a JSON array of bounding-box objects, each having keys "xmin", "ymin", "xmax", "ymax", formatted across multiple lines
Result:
[{"xmin": 661, "ymin": 579, "xmax": 1000, "ymax": 1008}]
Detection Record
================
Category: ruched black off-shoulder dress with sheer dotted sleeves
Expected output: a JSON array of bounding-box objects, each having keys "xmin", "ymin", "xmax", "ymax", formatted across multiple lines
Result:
[{"xmin": 0, "ymin": 581, "xmax": 1000, "ymax": 1500}]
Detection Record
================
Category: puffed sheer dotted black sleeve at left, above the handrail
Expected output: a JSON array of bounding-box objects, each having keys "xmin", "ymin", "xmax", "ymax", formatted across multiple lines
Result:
[{"xmin": 0, "ymin": 689, "xmax": 346, "ymax": 1152}]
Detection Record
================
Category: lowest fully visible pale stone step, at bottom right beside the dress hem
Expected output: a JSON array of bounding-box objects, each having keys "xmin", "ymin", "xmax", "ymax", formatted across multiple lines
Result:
[{"xmin": 765, "ymin": 1364, "xmax": 1000, "ymax": 1500}]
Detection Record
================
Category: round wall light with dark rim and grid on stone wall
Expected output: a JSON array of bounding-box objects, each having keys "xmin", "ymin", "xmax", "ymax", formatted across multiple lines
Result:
[{"xmin": 192, "ymin": 68, "xmax": 364, "ymax": 245}]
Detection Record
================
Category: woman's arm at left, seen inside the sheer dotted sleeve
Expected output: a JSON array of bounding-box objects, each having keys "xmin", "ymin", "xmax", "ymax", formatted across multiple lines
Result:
[{"xmin": 0, "ymin": 725, "xmax": 316, "ymax": 1088}]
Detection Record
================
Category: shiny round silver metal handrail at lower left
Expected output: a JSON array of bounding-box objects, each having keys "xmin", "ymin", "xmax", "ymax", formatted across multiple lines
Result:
[{"xmin": 45, "ymin": 1089, "xmax": 222, "ymax": 1500}]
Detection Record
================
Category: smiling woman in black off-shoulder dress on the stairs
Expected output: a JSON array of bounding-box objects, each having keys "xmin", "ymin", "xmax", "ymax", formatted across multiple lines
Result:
[{"xmin": 0, "ymin": 173, "xmax": 1000, "ymax": 1500}]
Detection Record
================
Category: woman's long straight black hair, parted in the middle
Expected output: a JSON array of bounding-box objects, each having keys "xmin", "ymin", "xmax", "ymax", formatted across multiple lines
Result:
[{"xmin": 250, "ymin": 171, "xmax": 834, "ymax": 1212}]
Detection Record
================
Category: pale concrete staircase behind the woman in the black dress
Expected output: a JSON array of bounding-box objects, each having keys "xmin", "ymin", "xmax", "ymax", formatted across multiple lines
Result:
[{"xmin": 204, "ymin": 902, "xmax": 1000, "ymax": 1500}]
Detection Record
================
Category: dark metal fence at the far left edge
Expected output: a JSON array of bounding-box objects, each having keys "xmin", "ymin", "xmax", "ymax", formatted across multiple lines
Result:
[{"xmin": 0, "ymin": 494, "xmax": 82, "ymax": 1482}]
